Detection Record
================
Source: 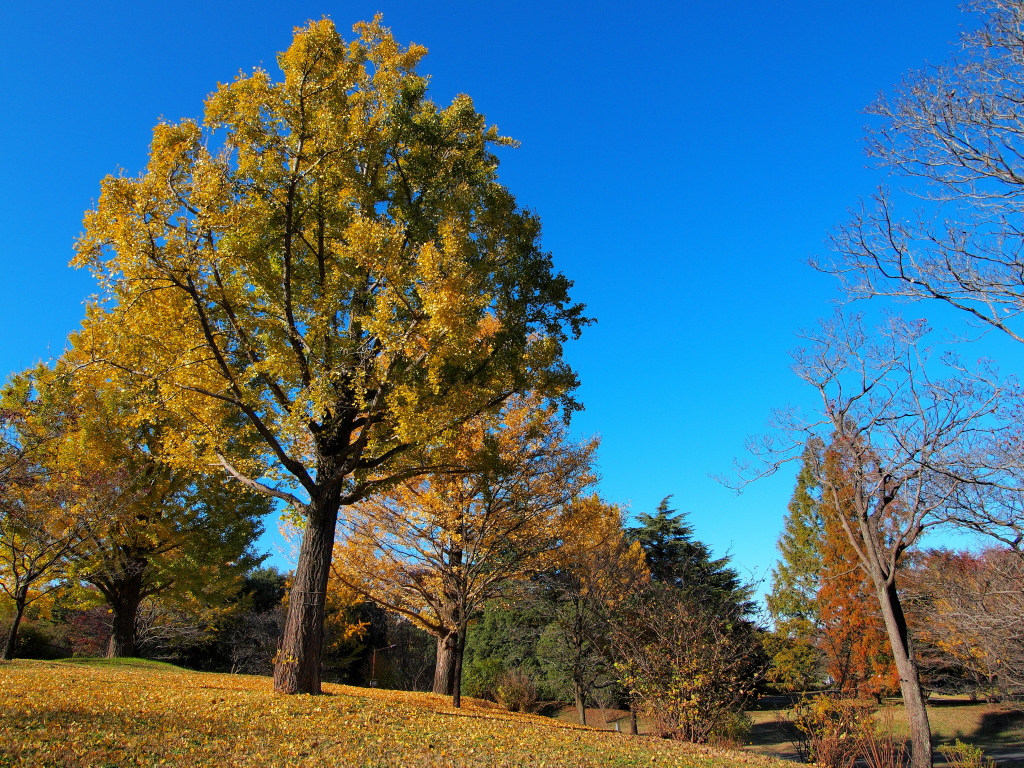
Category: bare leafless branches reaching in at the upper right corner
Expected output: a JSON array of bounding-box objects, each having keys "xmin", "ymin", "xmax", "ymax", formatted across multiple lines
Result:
[{"xmin": 819, "ymin": 0, "xmax": 1024, "ymax": 342}]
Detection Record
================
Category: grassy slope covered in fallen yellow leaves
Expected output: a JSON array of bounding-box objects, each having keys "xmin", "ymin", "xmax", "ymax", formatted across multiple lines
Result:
[{"xmin": 0, "ymin": 660, "xmax": 786, "ymax": 768}]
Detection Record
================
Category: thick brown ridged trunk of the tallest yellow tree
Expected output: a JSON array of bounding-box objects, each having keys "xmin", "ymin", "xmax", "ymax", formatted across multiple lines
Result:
[{"xmin": 273, "ymin": 501, "xmax": 339, "ymax": 693}]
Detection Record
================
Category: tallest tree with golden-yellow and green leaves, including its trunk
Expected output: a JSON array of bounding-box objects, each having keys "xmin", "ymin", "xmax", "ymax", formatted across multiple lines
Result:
[{"xmin": 75, "ymin": 19, "xmax": 585, "ymax": 693}]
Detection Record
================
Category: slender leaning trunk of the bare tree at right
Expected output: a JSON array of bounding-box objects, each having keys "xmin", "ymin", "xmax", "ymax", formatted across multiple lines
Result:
[{"xmin": 872, "ymin": 574, "xmax": 932, "ymax": 768}]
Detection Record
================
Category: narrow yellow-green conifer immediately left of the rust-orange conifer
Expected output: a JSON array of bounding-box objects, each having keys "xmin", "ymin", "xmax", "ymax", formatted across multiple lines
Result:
[{"xmin": 766, "ymin": 438, "xmax": 824, "ymax": 690}]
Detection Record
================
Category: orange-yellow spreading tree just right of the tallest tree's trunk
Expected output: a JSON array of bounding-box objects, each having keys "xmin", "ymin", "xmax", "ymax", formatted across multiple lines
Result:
[{"xmin": 336, "ymin": 398, "xmax": 596, "ymax": 707}]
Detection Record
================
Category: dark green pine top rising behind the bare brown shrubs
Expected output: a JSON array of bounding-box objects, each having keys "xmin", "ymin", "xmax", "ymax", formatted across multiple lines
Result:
[{"xmin": 627, "ymin": 496, "xmax": 756, "ymax": 615}]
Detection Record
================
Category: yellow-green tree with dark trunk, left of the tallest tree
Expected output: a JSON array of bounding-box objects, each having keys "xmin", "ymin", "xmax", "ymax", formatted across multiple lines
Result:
[{"xmin": 62, "ymin": 384, "xmax": 271, "ymax": 657}]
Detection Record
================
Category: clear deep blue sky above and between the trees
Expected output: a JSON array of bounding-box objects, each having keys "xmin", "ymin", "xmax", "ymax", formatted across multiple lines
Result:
[{"xmin": 0, "ymin": 0, "xmax": 973, "ymax": 593}]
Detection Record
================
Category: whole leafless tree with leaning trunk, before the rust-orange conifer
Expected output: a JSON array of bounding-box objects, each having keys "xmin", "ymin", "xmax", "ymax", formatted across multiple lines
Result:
[{"xmin": 771, "ymin": 314, "xmax": 1013, "ymax": 768}]
